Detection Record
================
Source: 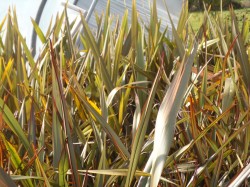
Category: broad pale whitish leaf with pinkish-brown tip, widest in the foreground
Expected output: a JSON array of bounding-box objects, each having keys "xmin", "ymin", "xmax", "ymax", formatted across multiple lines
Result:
[{"xmin": 150, "ymin": 42, "xmax": 198, "ymax": 186}]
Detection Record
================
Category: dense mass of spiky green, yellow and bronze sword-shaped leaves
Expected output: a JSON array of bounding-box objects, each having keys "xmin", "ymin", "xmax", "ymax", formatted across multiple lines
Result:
[{"xmin": 0, "ymin": 1, "xmax": 250, "ymax": 187}]
